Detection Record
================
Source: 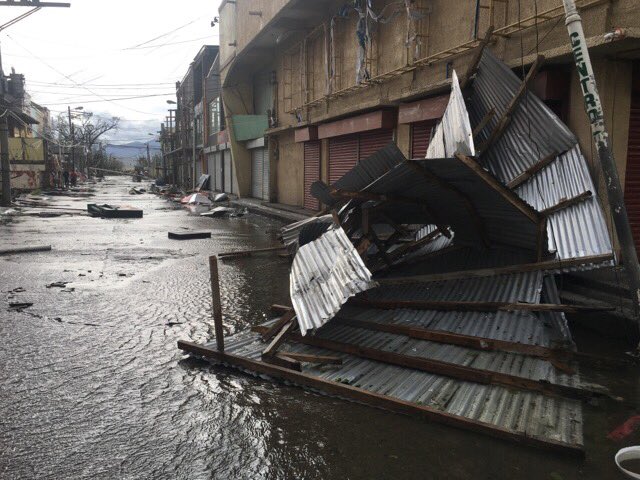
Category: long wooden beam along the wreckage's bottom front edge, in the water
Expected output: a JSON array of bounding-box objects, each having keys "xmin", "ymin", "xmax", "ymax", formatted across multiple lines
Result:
[{"xmin": 178, "ymin": 341, "xmax": 584, "ymax": 456}]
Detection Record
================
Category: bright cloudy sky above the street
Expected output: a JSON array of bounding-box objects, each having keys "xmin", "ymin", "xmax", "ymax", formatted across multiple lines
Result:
[{"xmin": 0, "ymin": 0, "xmax": 220, "ymax": 143}]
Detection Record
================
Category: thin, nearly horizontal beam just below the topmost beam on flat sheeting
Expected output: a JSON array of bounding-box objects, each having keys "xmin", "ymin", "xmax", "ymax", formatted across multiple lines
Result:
[{"xmin": 349, "ymin": 297, "xmax": 615, "ymax": 313}]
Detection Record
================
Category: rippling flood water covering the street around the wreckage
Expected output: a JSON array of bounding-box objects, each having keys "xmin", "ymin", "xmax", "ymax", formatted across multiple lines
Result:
[{"xmin": 0, "ymin": 177, "xmax": 640, "ymax": 480}]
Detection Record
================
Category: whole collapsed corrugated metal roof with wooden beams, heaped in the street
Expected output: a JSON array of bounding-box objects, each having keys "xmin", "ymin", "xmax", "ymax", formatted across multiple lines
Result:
[{"xmin": 179, "ymin": 35, "xmax": 614, "ymax": 454}]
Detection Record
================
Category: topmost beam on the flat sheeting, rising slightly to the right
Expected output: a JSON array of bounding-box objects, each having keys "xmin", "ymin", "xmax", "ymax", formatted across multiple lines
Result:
[{"xmin": 376, "ymin": 254, "xmax": 614, "ymax": 285}]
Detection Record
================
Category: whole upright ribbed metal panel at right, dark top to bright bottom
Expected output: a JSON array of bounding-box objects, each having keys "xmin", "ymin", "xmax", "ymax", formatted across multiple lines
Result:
[{"xmin": 469, "ymin": 49, "xmax": 612, "ymax": 270}]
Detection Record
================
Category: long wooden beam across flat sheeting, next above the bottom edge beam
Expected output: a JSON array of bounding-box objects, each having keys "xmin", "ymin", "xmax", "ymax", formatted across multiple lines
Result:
[{"xmin": 249, "ymin": 328, "xmax": 613, "ymax": 401}]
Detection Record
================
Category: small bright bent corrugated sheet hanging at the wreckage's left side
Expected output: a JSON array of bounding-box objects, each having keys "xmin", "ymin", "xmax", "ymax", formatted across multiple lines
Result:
[{"xmin": 289, "ymin": 227, "xmax": 375, "ymax": 335}]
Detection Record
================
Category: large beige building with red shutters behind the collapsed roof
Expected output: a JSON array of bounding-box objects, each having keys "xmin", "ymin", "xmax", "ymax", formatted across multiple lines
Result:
[{"xmin": 219, "ymin": 0, "xmax": 640, "ymax": 251}]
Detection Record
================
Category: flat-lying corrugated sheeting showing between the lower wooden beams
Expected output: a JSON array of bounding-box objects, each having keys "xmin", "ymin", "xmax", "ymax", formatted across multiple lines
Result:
[{"xmin": 211, "ymin": 272, "xmax": 583, "ymax": 445}]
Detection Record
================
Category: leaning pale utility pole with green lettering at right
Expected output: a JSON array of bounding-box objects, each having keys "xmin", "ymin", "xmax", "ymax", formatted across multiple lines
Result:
[{"xmin": 563, "ymin": 0, "xmax": 640, "ymax": 321}]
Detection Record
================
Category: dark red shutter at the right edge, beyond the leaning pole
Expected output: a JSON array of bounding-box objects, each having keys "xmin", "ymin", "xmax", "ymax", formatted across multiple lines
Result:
[{"xmin": 624, "ymin": 85, "xmax": 640, "ymax": 254}]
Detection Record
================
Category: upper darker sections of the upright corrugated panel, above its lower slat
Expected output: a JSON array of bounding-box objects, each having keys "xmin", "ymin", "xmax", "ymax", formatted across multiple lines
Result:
[{"xmin": 469, "ymin": 48, "xmax": 577, "ymax": 183}]
